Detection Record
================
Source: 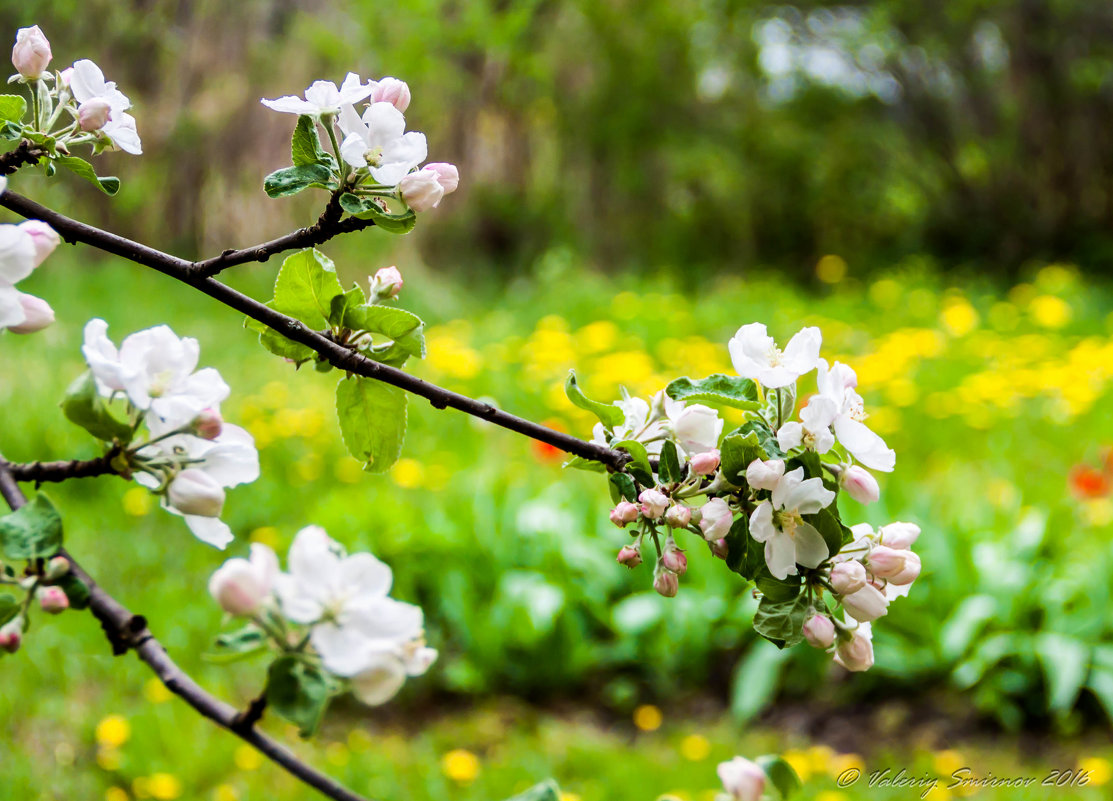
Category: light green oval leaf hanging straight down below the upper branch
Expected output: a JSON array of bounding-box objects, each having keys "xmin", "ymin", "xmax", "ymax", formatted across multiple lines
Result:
[{"xmin": 336, "ymin": 376, "xmax": 406, "ymax": 473}]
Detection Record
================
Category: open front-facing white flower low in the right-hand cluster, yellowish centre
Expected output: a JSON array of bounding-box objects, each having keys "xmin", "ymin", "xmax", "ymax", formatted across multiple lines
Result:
[{"xmin": 750, "ymin": 467, "xmax": 835, "ymax": 579}]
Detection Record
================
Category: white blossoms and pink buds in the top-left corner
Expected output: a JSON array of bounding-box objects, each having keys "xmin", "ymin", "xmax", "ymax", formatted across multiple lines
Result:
[{"xmin": 8, "ymin": 26, "xmax": 142, "ymax": 156}]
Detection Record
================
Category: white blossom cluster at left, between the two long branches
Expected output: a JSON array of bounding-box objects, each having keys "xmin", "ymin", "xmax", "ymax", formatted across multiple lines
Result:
[{"xmin": 79, "ymin": 319, "xmax": 259, "ymax": 548}]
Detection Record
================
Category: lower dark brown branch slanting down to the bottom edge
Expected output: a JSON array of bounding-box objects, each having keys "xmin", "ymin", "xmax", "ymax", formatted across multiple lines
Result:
[{"xmin": 0, "ymin": 463, "xmax": 367, "ymax": 801}]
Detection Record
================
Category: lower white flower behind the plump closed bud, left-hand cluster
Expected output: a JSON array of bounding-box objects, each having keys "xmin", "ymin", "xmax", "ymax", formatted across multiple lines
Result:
[{"xmin": 135, "ymin": 424, "xmax": 259, "ymax": 550}]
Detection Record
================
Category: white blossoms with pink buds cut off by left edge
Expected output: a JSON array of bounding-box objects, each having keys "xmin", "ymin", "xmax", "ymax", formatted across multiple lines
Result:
[{"xmin": 0, "ymin": 176, "xmax": 61, "ymax": 334}]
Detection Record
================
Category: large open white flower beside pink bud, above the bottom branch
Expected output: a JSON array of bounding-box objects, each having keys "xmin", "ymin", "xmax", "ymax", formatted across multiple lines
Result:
[{"xmin": 275, "ymin": 526, "xmax": 423, "ymax": 676}]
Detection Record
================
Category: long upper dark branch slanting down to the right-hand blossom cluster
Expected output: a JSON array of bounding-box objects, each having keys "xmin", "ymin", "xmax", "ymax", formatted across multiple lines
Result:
[{"xmin": 0, "ymin": 191, "xmax": 630, "ymax": 469}]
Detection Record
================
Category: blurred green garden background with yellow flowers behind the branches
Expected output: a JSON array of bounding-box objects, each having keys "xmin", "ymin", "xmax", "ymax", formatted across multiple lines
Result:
[{"xmin": 0, "ymin": 0, "xmax": 1113, "ymax": 801}]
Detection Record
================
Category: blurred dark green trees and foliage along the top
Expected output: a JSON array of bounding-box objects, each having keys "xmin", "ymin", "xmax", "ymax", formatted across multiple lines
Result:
[{"xmin": 0, "ymin": 0, "xmax": 1113, "ymax": 276}]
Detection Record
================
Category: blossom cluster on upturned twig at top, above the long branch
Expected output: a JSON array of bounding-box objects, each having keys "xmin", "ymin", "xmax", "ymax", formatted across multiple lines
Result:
[{"xmin": 262, "ymin": 72, "xmax": 460, "ymax": 211}]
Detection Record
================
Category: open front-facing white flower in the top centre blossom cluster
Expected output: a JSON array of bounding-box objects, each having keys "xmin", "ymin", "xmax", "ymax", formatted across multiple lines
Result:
[{"xmin": 338, "ymin": 102, "xmax": 429, "ymax": 186}]
